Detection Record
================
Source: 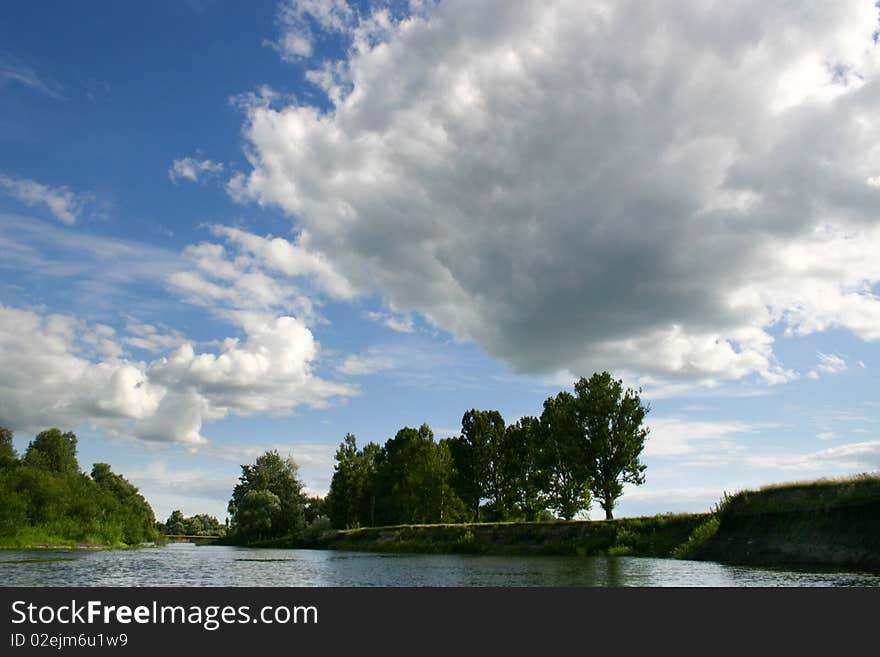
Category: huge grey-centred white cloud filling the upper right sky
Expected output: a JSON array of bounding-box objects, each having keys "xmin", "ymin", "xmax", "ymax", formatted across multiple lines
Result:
[{"xmin": 230, "ymin": 0, "xmax": 880, "ymax": 385}]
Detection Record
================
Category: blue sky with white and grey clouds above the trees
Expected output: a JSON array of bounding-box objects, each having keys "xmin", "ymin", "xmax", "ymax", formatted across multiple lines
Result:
[{"xmin": 0, "ymin": 0, "xmax": 880, "ymax": 519}]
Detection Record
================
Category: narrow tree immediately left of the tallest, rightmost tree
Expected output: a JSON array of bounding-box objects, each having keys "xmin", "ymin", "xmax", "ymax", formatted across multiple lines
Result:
[{"xmin": 539, "ymin": 392, "xmax": 590, "ymax": 520}]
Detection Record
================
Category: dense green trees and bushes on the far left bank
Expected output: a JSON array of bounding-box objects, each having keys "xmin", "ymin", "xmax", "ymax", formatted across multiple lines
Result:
[{"xmin": 0, "ymin": 427, "xmax": 157, "ymax": 547}]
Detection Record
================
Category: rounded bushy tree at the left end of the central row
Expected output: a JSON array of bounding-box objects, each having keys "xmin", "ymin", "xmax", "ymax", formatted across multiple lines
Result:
[{"xmin": 229, "ymin": 450, "xmax": 306, "ymax": 541}]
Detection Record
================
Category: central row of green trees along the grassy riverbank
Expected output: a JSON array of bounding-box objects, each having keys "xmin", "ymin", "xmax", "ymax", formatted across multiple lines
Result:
[{"xmin": 228, "ymin": 372, "xmax": 650, "ymax": 543}]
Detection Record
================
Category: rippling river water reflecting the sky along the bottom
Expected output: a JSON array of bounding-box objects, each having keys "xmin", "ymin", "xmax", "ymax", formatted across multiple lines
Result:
[{"xmin": 0, "ymin": 543, "xmax": 880, "ymax": 587}]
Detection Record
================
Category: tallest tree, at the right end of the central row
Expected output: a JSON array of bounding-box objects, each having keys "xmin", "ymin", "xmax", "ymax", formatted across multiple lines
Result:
[{"xmin": 574, "ymin": 372, "xmax": 650, "ymax": 520}]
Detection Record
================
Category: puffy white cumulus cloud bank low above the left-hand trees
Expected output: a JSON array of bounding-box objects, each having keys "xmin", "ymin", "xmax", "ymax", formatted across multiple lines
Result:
[{"xmin": 0, "ymin": 306, "xmax": 356, "ymax": 445}]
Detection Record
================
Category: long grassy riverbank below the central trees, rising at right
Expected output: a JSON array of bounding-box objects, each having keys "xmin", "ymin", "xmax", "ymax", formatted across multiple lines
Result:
[{"xmin": 244, "ymin": 475, "xmax": 880, "ymax": 572}]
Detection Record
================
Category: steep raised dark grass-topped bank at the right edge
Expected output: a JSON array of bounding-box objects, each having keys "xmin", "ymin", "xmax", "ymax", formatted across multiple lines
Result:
[{"xmin": 680, "ymin": 475, "xmax": 880, "ymax": 572}]
